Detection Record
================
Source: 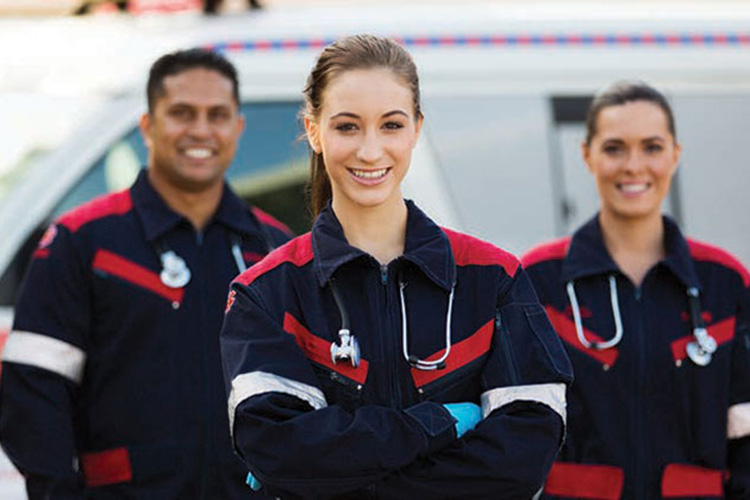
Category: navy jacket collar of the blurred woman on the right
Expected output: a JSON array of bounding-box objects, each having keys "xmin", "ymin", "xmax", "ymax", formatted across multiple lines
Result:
[{"xmin": 562, "ymin": 214, "xmax": 698, "ymax": 287}]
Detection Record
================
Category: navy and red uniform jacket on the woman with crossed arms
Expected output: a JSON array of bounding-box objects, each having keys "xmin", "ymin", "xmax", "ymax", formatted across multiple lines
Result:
[{"xmin": 221, "ymin": 202, "xmax": 572, "ymax": 498}]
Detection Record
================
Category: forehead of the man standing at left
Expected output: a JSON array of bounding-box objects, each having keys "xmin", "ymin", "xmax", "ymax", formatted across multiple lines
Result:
[{"xmin": 157, "ymin": 68, "xmax": 234, "ymax": 106}]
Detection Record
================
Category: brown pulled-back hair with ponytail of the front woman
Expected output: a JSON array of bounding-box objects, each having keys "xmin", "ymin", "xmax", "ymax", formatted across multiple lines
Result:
[{"xmin": 302, "ymin": 35, "xmax": 422, "ymax": 217}]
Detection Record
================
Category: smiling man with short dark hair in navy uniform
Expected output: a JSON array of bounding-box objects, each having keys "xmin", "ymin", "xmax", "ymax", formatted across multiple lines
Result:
[{"xmin": 0, "ymin": 49, "xmax": 289, "ymax": 500}]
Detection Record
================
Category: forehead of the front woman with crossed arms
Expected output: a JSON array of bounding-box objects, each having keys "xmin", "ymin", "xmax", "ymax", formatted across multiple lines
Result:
[{"xmin": 322, "ymin": 68, "xmax": 414, "ymax": 114}]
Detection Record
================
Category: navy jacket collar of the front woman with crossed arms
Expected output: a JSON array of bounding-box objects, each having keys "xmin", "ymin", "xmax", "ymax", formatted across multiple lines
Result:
[{"xmin": 312, "ymin": 200, "xmax": 456, "ymax": 291}]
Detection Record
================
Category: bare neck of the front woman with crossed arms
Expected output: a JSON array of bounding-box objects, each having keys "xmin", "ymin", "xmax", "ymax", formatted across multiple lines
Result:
[{"xmin": 332, "ymin": 197, "xmax": 407, "ymax": 265}]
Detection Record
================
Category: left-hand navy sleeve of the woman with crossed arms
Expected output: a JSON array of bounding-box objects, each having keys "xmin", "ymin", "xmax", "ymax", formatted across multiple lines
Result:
[{"xmin": 221, "ymin": 283, "xmax": 456, "ymax": 498}]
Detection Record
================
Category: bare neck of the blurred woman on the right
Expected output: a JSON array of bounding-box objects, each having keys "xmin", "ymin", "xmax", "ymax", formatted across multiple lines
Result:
[{"xmin": 599, "ymin": 211, "xmax": 666, "ymax": 286}]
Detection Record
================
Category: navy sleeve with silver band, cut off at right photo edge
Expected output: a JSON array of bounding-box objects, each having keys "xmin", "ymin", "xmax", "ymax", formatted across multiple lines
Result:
[{"xmin": 726, "ymin": 287, "xmax": 750, "ymax": 498}]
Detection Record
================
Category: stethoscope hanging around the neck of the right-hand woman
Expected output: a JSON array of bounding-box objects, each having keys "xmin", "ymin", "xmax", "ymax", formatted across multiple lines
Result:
[{"xmin": 565, "ymin": 274, "xmax": 717, "ymax": 366}]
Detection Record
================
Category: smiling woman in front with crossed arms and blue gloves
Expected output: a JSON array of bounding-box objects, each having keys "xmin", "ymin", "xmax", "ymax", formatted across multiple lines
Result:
[{"xmin": 221, "ymin": 36, "xmax": 571, "ymax": 498}]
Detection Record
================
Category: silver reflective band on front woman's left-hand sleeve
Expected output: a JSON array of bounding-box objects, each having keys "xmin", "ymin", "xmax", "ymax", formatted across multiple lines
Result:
[{"xmin": 229, "ymin": 372, "xmax": 328, "ymax": 433}]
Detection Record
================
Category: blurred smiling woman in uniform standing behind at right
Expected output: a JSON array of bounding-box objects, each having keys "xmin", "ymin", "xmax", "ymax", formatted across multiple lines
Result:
[{"xmin": 522, "ymin": 82, "xmax": 750, "ymax": 499}]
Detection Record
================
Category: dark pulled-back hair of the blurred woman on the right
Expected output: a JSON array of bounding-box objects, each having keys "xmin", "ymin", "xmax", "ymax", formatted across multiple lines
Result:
[{"xmin": 586, "ymin": 81, "xmax": 677, "ymax": 146}]
